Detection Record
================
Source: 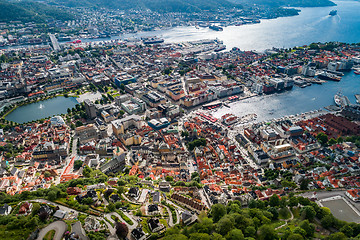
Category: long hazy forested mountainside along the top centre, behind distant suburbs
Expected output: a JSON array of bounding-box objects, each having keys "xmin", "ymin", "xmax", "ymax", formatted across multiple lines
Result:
[{"xmin": 46, "ymin": 0, "xmax": 241, "ymax": 12}]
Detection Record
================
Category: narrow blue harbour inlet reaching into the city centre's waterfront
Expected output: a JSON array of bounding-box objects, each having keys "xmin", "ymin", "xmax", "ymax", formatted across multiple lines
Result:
[{"xmin": 213, "ymin": 72, "xmax": 360, "ymax": 121}]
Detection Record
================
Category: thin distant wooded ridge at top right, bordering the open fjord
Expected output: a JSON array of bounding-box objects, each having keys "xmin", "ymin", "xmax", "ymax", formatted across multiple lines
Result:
[{"xmin": 231, "ymin": 0, "xmax": 336, "ymax": 7}]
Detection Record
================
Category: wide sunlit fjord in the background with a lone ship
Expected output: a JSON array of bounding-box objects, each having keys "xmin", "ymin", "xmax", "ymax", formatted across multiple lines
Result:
[{"xmin": 139, "ymin": 1, "xmax": 360, "ymax": 51}]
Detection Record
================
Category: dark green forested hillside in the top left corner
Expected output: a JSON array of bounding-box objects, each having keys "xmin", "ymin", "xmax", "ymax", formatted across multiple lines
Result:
[{"xmin": 0, "ymin": 0, "xmax": 74, "ymax": 22}]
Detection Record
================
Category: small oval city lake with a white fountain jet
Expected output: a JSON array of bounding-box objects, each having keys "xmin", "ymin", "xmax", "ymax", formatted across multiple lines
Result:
[{"xmin": 5, "ymin": 97, "xmax": 78, "ymax": 123}]
